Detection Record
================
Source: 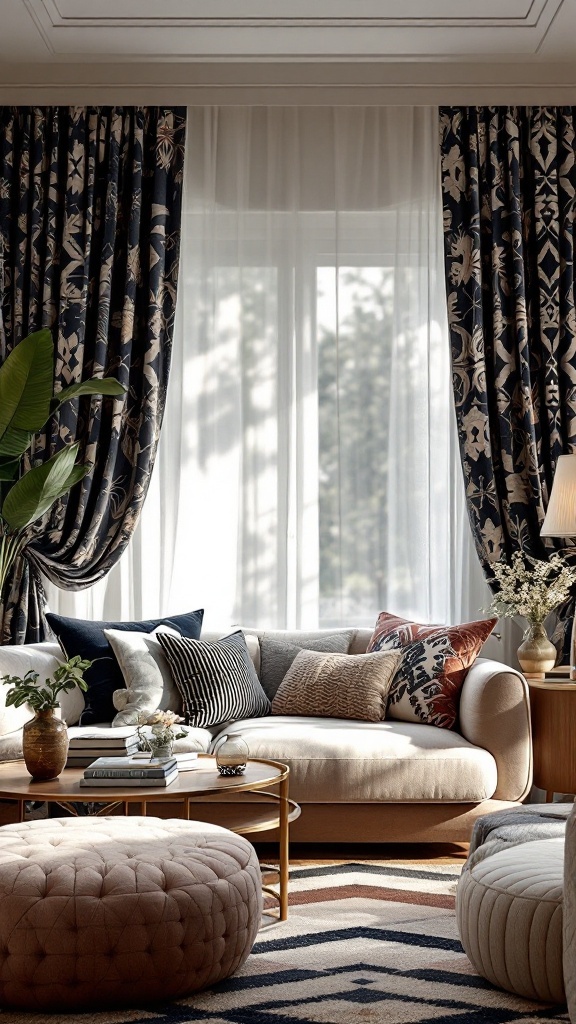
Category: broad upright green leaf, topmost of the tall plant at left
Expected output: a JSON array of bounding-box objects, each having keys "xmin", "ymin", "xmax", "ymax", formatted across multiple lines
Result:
[{"xmin": 0, "ymin": 330, "xmax": 54, "ymax": 455}]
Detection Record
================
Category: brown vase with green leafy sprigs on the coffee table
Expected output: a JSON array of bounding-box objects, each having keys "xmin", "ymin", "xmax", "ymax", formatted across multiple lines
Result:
[{"xmin": 0, "ymin": 655, "xmax": 92, "ymax": 782}]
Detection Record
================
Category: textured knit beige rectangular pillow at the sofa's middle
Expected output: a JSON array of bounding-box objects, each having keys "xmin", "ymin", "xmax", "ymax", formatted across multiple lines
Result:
[{"xmin": 272, "ymin": 650, "xmax": 402, "ymax": 722}]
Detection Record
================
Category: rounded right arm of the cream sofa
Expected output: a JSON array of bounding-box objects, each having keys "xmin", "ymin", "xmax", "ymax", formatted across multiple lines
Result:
[{"xmin": 460, "ymin": 657, "xmax": 532, "ymax": 801}]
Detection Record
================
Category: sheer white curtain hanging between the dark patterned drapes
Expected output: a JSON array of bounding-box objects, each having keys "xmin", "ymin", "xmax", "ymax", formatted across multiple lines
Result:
[{"xmin": 45, "ymin": 106, "xmax": 494, "ymax": 628}]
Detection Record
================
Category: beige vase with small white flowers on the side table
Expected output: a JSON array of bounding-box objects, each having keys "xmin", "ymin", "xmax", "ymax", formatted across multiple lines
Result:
[{"xmin": 483, "ymin": 551, "xmax": 576, "ymax": 678}]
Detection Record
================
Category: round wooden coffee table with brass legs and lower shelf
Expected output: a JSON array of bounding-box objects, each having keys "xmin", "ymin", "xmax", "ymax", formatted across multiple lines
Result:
[{"xmin": 0, "ymin": 754, "xmax": 300, "ymax": 921}]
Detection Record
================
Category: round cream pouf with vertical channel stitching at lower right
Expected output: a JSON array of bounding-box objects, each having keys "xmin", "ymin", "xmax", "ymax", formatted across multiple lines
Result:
[{"xmin": 456, "ymin": 839, "xmax": 565, "ymax": 1002}]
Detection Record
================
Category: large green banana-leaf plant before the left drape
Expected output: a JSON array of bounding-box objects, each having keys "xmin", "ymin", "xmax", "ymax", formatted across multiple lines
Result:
[{"xmin": 0, "ymin": 330, "xmax": 126, "ymax": 602}]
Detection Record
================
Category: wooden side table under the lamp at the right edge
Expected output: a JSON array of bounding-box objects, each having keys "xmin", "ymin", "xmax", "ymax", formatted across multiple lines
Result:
[{"xmin": 528, "ymin": 679, "xmax": 576, "ymax": 801}]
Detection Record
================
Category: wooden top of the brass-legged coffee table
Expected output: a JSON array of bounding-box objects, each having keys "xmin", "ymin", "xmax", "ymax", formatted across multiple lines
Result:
[{"xmin": 0, "ymin": 754, "xmax": 289, "ymax": 804}]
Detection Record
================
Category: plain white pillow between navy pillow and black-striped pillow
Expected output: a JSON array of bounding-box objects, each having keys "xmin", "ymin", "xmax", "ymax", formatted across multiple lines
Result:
[{"xmin": 104, "ymin": 626, "xmax": 182, "ymax": 726}]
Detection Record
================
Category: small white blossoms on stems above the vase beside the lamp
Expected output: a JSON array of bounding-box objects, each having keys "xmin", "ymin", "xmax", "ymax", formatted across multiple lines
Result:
[{"xmin": 489, "ymin": 551, "xmax": 576, "ymax": 625}]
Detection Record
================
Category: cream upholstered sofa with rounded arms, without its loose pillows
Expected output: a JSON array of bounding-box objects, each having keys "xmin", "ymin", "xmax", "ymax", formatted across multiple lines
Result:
[{"xmin": 0, "ymin": 629, "xmax": 532, "ymax": 843}]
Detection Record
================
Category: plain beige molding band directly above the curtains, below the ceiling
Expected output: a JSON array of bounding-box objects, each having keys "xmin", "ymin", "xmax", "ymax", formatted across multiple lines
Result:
[{"xmin": 0, "ymin": 61, "xmax": 576, "ymax": 105}]
